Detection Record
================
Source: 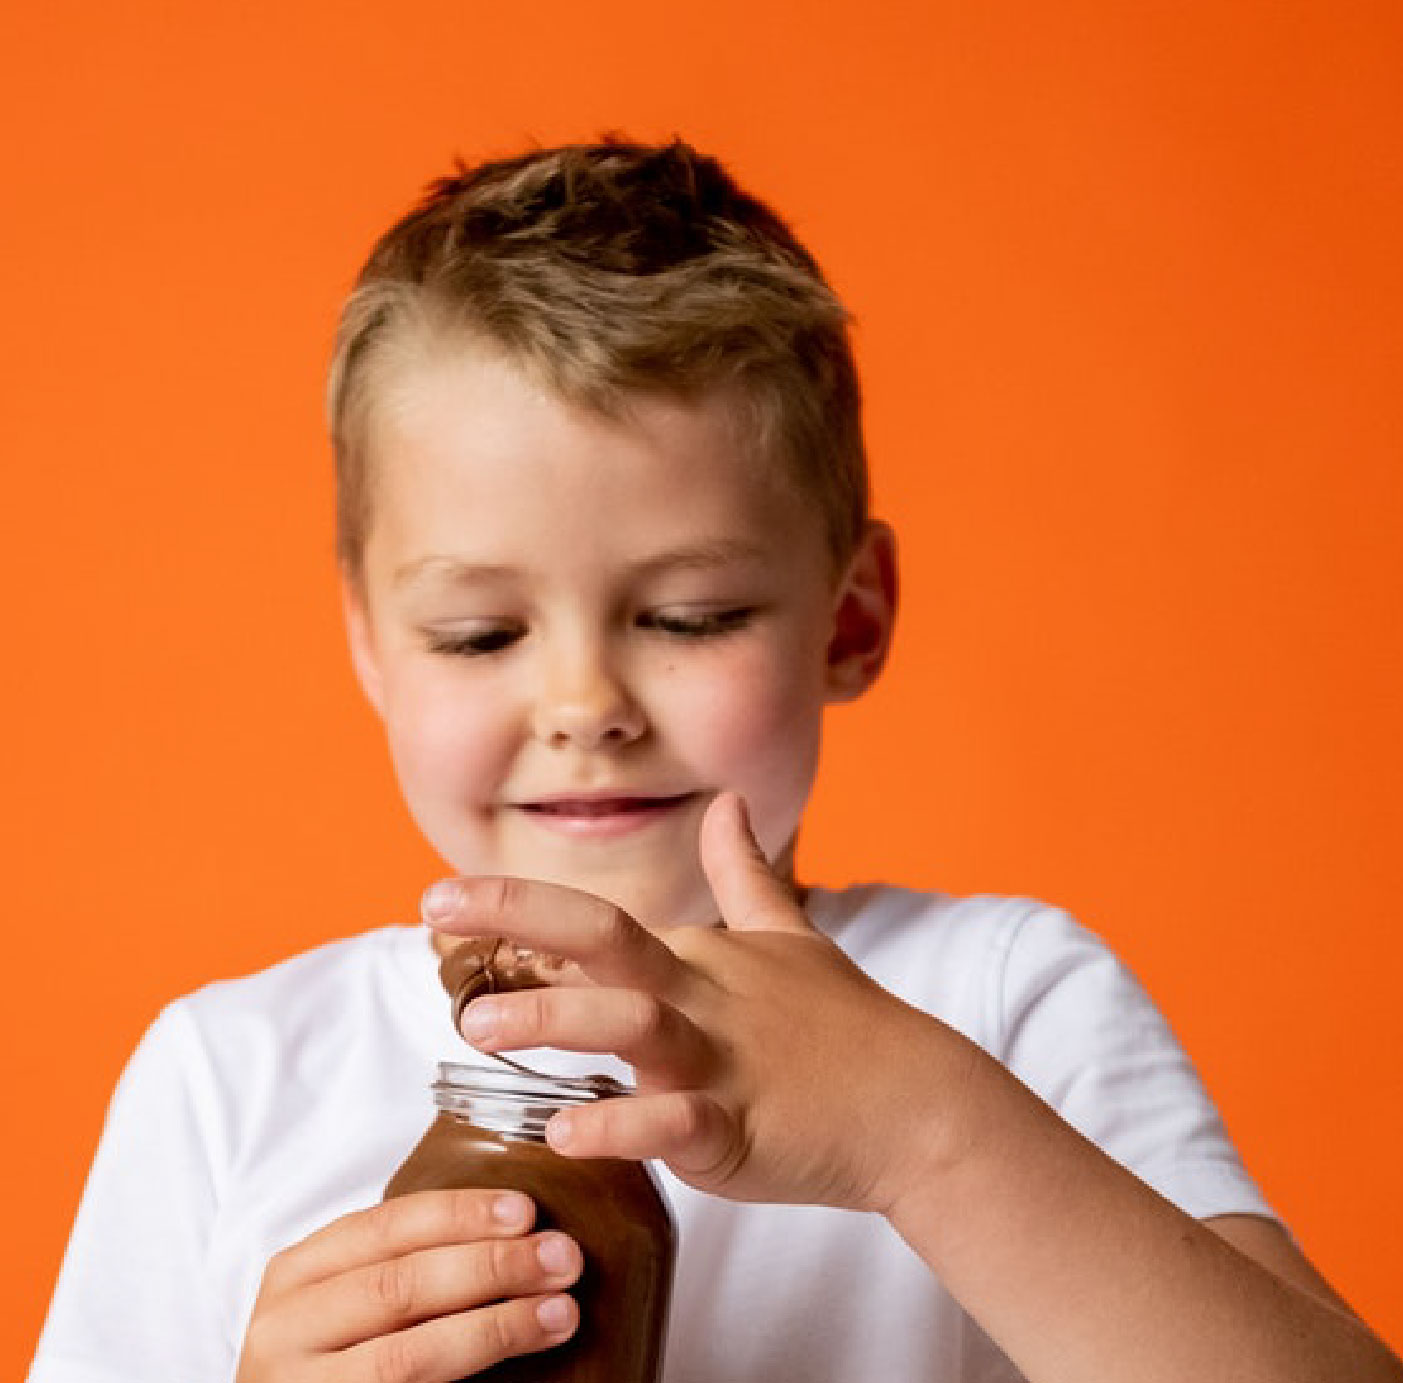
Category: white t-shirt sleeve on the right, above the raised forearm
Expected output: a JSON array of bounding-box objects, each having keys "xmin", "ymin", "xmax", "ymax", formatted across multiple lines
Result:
[{"xmin": 992, "ymin": 906, "xmax": 1275, "ymax": 1219}]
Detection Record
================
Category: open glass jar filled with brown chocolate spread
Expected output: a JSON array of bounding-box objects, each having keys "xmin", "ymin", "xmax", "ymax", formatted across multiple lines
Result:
[{"xmin": 384, "ymin": 1062, "xmax": 676, "ymax": 1383}]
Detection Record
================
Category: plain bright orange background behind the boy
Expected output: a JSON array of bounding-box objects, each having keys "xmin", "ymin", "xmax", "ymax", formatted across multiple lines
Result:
[{"xmin": 8, "ymin": 0, "xmax": 1403, "ymax": 1376}]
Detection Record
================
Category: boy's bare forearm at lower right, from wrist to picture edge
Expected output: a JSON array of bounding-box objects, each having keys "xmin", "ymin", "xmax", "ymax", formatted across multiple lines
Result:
[{"xmin": 888, "ymin": 1052, "xmax": 1403, "ymax": 1383}]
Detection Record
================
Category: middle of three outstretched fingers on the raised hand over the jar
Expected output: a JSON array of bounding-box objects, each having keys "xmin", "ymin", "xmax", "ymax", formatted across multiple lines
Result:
[{"xmin": 460, "ymin": 987, "xmax": 716, "ymax": 1086}]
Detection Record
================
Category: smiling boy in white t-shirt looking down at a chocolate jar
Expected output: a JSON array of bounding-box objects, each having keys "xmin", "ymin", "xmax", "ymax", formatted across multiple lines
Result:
[{"xmin": 31, "ymin": 144, "xmax": 1403, "ymax": 1383}]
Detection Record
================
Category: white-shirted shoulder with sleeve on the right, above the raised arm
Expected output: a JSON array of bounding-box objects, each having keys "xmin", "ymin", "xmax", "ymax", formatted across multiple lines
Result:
[{"xmin": 810, "ymin": 885, "xmax": 1271, "ymax": 1217}]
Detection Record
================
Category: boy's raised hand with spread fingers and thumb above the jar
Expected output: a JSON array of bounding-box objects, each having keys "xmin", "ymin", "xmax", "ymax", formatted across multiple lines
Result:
[{"xmin": 425, "ymin": 794, "xmax": 979, "ymax": 1212}]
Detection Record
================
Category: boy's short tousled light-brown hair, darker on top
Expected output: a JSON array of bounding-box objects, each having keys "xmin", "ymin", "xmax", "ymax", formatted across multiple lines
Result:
[{"xmin": 327, "ymin": 137, "xmax": 868, "ymax": 578}]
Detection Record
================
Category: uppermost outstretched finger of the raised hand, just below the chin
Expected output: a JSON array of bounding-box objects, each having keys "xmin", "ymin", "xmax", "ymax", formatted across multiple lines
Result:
[{"xmin": 421, "ymin": 878, "xmax": 686, "ymax": 993}]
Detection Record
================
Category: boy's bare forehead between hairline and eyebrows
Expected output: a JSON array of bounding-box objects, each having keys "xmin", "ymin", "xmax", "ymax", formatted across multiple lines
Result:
[{"xmin": 368, "ymin": 339, "xmax": 822, "ymax": 563}]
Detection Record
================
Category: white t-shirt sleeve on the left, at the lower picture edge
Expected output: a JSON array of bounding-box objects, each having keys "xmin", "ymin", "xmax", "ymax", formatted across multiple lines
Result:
[{"xmin": 29, "ymin": 1003, "xmax": 237, "ymax": 1383}]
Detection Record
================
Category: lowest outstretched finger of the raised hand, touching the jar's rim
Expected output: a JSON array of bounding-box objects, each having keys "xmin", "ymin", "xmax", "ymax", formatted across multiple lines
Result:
[{"xmin": 546, "ymin": 1091, "xmax": 745, "ymax": 1187}]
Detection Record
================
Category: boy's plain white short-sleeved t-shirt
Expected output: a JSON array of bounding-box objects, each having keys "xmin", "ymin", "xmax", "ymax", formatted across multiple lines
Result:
[{"xmin": 29, "ymin": 886, "xmax": 1271, "ymax": 1383}]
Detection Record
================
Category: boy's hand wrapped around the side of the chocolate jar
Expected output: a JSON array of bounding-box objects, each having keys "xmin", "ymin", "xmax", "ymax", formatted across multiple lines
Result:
[{"xmin": 236, "ymin": 1191, "xmax": 582, "ymax": 1383}]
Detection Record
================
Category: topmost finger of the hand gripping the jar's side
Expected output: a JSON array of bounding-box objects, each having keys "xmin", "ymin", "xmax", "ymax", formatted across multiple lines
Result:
[{"xmin": 264, "ymin": 1189, "xmax": 536, "ymax": 1295}]
